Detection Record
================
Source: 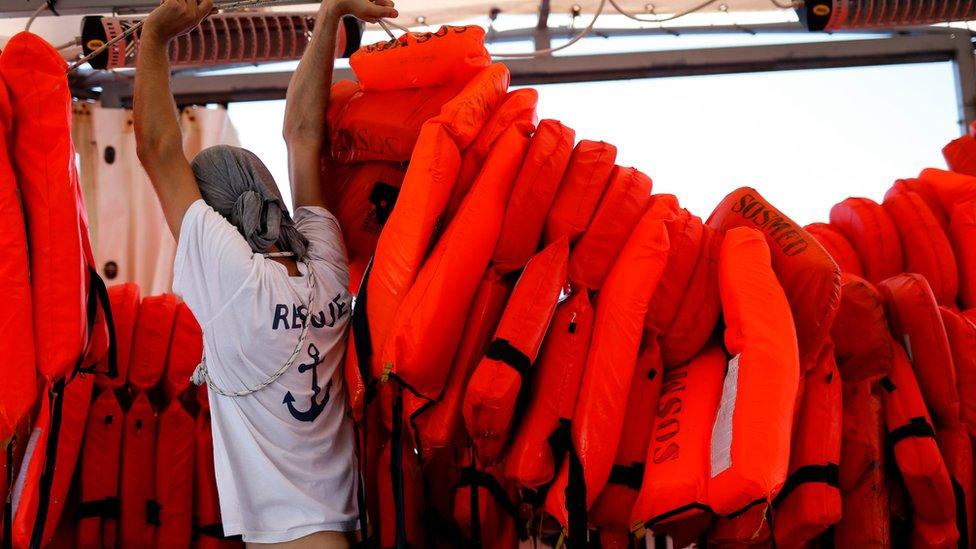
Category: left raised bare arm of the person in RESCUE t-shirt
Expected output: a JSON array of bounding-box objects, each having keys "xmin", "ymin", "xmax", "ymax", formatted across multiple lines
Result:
[{"xmin": 132, "ymin": 0, "xmax": 213, "ymax": 239}]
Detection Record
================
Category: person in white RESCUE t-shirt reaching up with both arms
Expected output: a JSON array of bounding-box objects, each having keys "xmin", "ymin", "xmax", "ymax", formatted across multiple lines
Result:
[{"xmin": 133, "ymin": 0, "xmax": 397, "ymax": 548}]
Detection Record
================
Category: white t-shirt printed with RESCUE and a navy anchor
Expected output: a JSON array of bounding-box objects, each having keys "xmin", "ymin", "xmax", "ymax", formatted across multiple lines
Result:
[{"xmin": 173, "ymin": 200, "xmax": 358, "ymax": 543}]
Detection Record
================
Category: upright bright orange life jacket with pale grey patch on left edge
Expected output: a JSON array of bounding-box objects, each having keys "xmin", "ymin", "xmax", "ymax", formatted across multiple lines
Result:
[{"xmin": 708, "ymin": 227, "xmax": 800, "ymax": 515}]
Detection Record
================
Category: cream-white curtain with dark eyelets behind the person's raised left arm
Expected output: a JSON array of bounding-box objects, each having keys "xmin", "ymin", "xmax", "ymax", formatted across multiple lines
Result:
[{"xmin": 72, "ymin": 103, "xmax": 238, "ymax": 295}]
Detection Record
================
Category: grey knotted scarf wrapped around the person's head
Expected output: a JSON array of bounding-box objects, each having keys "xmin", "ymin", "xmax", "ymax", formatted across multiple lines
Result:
[{"xmin": 191, "ymin": 145, "xmax": 308, "ymax": 261}]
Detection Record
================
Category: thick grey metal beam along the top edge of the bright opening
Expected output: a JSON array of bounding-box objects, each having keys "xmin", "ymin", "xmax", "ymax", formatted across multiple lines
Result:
[{"xmin": 82, "ymin": 33, "xmax": 976, "ymax": 107}]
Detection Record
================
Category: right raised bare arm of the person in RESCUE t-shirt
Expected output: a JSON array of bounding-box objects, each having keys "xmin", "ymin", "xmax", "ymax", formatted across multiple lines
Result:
[{"xmin": 283, "ymin": 0, "xmax": 397, "ymax": 209}]
